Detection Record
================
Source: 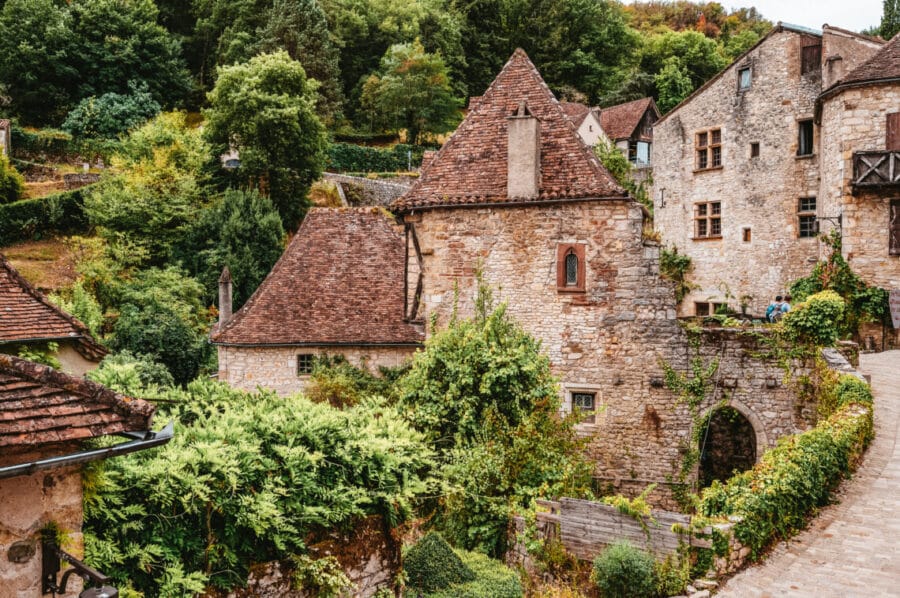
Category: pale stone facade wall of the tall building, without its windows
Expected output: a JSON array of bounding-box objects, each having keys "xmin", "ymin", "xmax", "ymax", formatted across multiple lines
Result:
[{"xmin": 651, "ymin": 30, "xmax": 821, "ymax": 315}]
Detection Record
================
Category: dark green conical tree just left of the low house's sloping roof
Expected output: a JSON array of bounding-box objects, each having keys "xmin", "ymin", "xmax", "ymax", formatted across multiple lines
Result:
[{"xmin": 177, "ymin": 189, "xmax": 284, "ymax": 310}]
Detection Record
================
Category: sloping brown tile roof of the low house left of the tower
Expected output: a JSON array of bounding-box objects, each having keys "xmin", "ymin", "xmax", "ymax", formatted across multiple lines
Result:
[{"xmin": 212, "ymin": 208, "xmax": 424, "ymax": 346}]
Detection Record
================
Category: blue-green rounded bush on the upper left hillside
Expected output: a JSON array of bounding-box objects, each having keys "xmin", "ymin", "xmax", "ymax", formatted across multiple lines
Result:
[{"xmin": 62, "ymin": 81, "xmax": 160, "ymax": 139}]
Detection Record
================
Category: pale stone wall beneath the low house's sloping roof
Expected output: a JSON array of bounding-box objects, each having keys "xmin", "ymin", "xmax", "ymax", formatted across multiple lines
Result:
[{"xmin": 217, "ymin": 345, "xmax": 415, "ymax": 396}]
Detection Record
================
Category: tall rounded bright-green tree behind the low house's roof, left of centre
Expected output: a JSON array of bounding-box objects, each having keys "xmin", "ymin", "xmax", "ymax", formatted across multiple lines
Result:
[{"xmin": 204, "ymin": 51, "xmax": 326, "ymax": 230}]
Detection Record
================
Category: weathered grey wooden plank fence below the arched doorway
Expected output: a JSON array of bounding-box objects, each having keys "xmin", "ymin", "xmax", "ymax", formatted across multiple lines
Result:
[{"xmin": 537, "ymin": 498, "xmax": 711, "ymax": 560}]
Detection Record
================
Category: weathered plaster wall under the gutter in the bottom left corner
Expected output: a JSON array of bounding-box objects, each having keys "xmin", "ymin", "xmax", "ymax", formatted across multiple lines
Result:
[{"xmin": 0, "ymin": 446, "xmax": 83, "ymax": 598}]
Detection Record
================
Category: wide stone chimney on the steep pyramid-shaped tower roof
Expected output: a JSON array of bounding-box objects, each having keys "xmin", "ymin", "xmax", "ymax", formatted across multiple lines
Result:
[{"xmin": 506, "ymin": 102, "xmax": 541, "ymax": 199}]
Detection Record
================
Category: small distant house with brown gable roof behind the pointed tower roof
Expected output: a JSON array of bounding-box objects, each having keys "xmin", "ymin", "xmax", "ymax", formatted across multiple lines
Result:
[{"xmin": 600, "ymin": 98, "xmax": 659, "ymax": 168}]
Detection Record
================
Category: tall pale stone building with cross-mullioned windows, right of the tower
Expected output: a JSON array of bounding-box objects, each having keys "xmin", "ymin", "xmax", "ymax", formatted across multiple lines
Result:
[{"xmin": 652, "ymin": 23, "xmax": 883, "ymax": 315}]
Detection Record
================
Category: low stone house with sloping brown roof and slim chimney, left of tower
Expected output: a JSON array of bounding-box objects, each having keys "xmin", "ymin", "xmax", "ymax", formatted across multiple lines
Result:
[{"xmin": 212, "ymin": 208, "xmax": 424, "ymax": 395}]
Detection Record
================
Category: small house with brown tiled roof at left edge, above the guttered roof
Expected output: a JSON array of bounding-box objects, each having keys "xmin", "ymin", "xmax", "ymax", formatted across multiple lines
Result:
[{"xmin": 0, "ymin": 255, "xmax": 106, "ymax": 376}]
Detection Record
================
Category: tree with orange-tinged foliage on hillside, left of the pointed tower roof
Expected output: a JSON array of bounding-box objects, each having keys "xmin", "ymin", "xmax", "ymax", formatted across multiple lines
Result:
[{"xmin": 360, "ymin": 39, "xmax": 460, "ymax": 144}]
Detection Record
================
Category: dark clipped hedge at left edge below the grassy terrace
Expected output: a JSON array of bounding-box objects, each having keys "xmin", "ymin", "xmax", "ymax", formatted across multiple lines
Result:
[{"xmin": 0, "ymin": 186, "xmax": 91, "ymax": 247}]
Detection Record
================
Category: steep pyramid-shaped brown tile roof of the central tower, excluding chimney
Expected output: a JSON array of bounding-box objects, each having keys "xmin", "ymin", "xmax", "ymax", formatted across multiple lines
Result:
[{"xmin": 391, "ymin": 49, "xmax": 626, "ymax": 212}]
